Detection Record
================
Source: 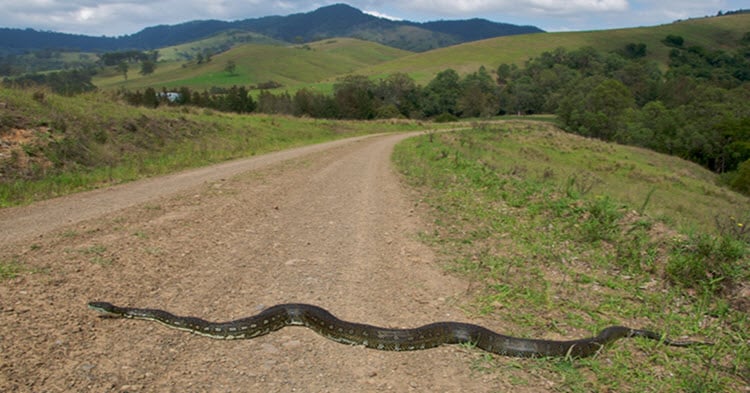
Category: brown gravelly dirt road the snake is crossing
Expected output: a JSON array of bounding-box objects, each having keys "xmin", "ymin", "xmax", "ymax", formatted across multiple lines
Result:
[{"xmin": 0, "ymin": 135, "xmax": 524, "ymax": 392}]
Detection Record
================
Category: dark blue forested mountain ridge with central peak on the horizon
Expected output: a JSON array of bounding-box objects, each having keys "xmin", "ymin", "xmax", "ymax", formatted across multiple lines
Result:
[{"xmin": 0, "ymin": 4, "xmax": 543, "ymax": 53}]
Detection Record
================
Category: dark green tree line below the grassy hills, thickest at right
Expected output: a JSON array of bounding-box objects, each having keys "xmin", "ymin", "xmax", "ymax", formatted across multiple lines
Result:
[{"xmin": 22, "ymin": 33, "xmax": 750, "ymax": 193}]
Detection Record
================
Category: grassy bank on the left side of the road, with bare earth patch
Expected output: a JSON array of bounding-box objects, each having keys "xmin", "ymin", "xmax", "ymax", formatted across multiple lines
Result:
[{"xmin": 0, "ymin": 88, "xmax": 434, "ymax": 207}]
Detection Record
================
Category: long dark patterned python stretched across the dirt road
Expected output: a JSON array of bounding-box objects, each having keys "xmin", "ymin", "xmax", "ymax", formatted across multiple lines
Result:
[{"xmin": 88, "ymin": 302, "xmax": 711, "ymax": 358}]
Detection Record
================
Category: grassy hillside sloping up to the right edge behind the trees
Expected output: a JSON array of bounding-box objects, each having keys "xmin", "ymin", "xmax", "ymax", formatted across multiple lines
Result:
[{"xmin": 359, "ymin": 14, "xmax": 750, "ymax": 83}]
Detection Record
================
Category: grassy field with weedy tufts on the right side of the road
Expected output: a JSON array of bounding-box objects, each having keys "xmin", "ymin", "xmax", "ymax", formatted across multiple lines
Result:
[{"xmin": 394, "ymin": 121, "xmax": 750, "ymax": 392}]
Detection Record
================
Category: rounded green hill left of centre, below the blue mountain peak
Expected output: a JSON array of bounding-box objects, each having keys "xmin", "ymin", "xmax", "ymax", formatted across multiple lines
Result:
[{"xmin": 94, "ymin": 38, "xmax": 411, "ymax": 89}]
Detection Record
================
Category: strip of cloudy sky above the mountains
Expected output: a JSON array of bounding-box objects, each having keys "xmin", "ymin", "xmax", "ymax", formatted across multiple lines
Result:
[{"xmin": 0, "ymin": 0, "xmax": 750, "ymax": 36}]
